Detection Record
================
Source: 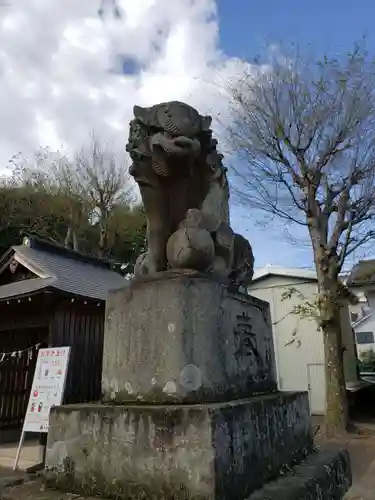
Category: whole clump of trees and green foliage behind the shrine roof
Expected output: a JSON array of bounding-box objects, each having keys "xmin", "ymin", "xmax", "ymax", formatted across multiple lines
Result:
[{"xmin": 0, "ymin": 138, "xmax": 146, "ymax": 272}]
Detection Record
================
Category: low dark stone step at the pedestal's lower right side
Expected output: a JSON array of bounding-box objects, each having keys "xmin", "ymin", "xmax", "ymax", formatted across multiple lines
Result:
[{"xmin": 247, "ymin": 448, "xmax": 351, "ymax": 500}]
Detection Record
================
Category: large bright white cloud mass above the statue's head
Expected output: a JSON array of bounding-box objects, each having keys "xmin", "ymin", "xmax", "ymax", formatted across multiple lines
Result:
[{"xmin": 0, "ymin": 0, "xmax": 251, "ymax": 170}]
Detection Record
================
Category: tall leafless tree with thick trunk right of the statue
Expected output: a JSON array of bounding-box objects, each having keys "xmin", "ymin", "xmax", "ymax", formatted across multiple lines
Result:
[{"xmin": 227, "ymin": 46, "xmax": 375, "ymax": 434}]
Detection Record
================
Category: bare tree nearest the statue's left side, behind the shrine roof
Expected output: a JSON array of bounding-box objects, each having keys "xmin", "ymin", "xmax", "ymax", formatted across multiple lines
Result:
[{"xmin": 75, "ymin": 135, "xmax": 133, "ymax": 257}]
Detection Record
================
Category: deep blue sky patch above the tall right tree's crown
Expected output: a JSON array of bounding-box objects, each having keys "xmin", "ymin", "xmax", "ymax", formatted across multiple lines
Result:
[{"xmin": 217, "ymin": 0, "xmax": 375, "ymax": 58}]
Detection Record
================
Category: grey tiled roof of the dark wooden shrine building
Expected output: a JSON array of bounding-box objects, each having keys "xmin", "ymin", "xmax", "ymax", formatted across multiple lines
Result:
[{"xmin": 0, "ymin": 239, "xmax": 126, "ymax": 300}]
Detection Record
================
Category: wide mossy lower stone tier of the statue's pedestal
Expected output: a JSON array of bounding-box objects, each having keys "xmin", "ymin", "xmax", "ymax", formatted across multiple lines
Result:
[{"xmin": 46, "ymin": 393, "xmax": 313, "ymax": 500}]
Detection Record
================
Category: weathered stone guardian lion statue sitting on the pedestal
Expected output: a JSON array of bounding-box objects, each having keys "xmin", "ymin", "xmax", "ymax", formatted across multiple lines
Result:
[{"xmin": 126, "ymin": 101, "xmax": 254, "ymax": 285}]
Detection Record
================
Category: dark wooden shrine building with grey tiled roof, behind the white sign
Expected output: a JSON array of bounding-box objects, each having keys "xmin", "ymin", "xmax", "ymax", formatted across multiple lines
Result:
[{"xmin": 0, "ymin": 237, "xmax": 124, "ymax": 442}]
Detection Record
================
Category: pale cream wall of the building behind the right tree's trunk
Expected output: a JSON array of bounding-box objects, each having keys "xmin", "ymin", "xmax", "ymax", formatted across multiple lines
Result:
[{"xmin": 249, "ymin": 276, "xmax": 357, "ymax": 413}]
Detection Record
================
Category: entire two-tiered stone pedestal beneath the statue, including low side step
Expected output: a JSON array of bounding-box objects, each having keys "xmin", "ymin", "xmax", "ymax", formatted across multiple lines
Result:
[{"xmin": 46, "ymin": 273, "xmax": 351, "ymax": 500}]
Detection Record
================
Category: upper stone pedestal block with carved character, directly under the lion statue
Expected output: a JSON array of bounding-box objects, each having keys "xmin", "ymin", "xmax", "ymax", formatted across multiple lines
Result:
[{"xmin": 102, "ymin": 272, "xmax": 277, "ymax": 403}]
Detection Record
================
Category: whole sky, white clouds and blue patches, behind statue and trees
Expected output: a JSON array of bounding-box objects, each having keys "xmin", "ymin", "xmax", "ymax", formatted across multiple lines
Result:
[{"xmin": 0, "ymin": 0, "xmax": 375, "ymax": 267}]
